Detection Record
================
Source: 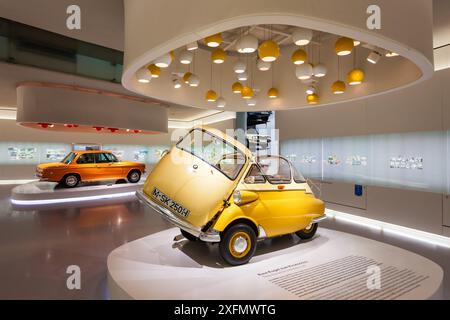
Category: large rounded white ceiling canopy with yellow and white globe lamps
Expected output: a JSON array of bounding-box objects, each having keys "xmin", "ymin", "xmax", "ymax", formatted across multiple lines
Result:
[{"xmin": 122, "ymin": 0, "xmax": 433, "ymax": 111}]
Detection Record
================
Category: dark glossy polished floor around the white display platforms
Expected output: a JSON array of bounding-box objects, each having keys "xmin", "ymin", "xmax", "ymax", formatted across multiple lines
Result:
[{"xmin": 0, "ymin": 186, "xmax": 450, "ymax": 299}]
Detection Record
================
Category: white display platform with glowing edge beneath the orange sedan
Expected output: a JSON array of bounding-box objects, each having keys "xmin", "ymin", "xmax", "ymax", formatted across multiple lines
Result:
[{"xmin": 11, "ymin": 180, "xmax": 144, "ymax": 206}]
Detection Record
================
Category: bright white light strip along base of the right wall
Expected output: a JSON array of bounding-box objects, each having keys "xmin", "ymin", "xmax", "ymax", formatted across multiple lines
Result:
[{"xmin": 325, "ymin": 209, "xmax": 450, "ymax": 248}]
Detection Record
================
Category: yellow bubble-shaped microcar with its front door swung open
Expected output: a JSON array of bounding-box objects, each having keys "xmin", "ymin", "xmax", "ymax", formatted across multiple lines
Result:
[{"xmin": 137, "ymin": 127, "xmax": 325, "ymax": 265}]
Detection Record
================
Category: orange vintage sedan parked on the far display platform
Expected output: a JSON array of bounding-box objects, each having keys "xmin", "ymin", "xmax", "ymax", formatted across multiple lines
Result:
[{"xmin": 36, "ymin": 151, "xmax": 145, "ymax": 188}]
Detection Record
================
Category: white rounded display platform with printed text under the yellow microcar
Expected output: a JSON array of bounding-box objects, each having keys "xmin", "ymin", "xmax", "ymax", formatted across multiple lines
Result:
[{"xmin": 108, "ymin": 228, "xmax": 443, "ymax": 300}]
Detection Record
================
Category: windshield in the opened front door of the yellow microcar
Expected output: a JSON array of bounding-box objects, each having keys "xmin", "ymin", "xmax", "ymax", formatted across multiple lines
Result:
[{"xmin": 177, "ymin": 129, "xmax": 246, "ymax": 180}]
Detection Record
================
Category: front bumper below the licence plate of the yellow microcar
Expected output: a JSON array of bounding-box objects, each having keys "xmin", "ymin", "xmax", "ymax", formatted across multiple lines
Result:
[{"xmin": 136, "ymin": 190, "xmax": 220, "ymax": 242}]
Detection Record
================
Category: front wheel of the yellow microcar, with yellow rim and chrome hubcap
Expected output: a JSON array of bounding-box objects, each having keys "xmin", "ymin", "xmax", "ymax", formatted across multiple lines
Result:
[{"xmin": 219, "ymin": 223, "xmax": 256, "ymax": 266}]
